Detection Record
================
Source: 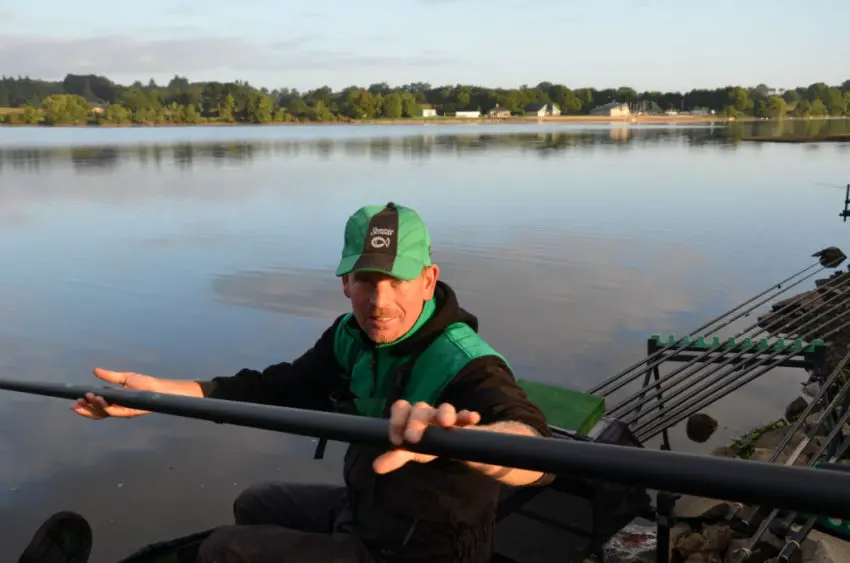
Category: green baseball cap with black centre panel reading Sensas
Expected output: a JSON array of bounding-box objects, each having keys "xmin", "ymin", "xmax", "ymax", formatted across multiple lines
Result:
[{"xmin": 336, "ymin": 202, "xmax": 431, "ymax": 280}]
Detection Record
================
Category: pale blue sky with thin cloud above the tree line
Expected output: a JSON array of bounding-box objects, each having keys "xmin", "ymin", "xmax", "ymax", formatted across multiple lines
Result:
[{"xmin": 0, "ymin": 0, "xmax": 850, "ymax": 91}]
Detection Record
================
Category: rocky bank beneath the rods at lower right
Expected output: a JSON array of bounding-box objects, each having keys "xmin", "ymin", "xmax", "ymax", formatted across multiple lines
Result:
[{"xmin": 604, "ymin": 268, "xmax": 850, "ymax": 563}]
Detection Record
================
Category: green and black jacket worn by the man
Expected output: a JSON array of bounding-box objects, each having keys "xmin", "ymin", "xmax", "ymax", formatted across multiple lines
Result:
[{"xmin": 202, "ymin": 282, "xmax": 551, "ymax": 562}]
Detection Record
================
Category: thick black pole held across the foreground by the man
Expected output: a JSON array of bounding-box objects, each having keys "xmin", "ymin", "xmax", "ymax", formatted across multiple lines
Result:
[{"xmin": 6, "ymin": 379, "xmax": 850, "ymax": 518}]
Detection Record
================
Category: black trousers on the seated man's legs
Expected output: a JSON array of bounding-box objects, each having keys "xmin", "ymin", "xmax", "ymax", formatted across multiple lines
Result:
[{"xmin": 198, "ymin": 483, "xmax": 374, "ymax": 563}]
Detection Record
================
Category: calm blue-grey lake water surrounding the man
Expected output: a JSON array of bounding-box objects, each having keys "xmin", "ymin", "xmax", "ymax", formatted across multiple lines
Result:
[{"xmin": 0, "ymin": 120, "xmax": 850, "ymax": 563}]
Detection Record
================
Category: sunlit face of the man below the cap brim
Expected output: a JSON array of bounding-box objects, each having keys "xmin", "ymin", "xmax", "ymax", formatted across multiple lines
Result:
[{"xmin": 342, "ymin": 265, "xmax": 439, "ymax": 344}]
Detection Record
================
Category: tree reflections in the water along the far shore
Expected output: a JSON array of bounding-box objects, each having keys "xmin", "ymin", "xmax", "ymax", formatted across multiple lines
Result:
[{"xmin": 0, "ymin": 119, "xmax": 850, "ymax": 172}]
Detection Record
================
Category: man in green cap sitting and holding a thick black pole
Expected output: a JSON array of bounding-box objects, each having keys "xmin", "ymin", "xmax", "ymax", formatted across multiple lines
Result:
[{"xmin": 72, "ymin": 203, "xmax": 550, "ymax": 563}]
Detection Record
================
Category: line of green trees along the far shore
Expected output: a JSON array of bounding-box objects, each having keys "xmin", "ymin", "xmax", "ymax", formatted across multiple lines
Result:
[{"xmin": 0, "ymin": 74, "xmax": 850, "ymax": 125}]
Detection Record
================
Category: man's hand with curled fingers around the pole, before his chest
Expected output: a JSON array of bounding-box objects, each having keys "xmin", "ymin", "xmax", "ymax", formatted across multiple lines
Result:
[{"xmin": 372, "ymin": 400, "xmax": 481, "ymax": 474}]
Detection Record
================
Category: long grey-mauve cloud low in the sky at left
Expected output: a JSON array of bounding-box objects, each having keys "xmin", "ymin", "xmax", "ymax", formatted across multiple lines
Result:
[{"xmin": 0, "ymin": 34, "xmax": 453, "ymax": 77}]
